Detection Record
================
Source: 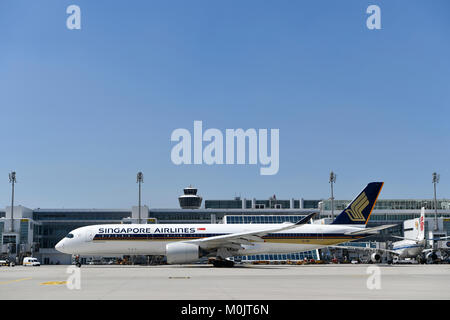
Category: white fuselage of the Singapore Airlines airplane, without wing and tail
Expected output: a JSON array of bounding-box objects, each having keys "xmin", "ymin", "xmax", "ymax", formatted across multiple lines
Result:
[{"xmin": 55, "ymin": 224, "xmax": 370, "ymax": 256}]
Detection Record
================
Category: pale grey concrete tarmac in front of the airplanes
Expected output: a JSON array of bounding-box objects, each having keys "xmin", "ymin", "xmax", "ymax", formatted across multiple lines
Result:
[{"xmin": 0, "ymin": 265, "xmax": 450, "ymax": 300}]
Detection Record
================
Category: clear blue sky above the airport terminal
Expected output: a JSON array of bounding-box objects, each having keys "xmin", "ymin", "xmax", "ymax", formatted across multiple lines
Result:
[{"xmin": 0, "ymin": 0, "xmax": 450, "ymax": 208}]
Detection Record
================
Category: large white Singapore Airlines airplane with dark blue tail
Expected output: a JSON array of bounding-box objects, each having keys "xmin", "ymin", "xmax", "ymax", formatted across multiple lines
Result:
[{"xmin": 55, "ymin": 182, "xmax": 392, "ymax": 267}]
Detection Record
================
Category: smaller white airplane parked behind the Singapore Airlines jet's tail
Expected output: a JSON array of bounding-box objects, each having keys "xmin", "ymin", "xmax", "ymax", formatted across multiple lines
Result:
[{"xmin": 331, "ymin": 207, "xmax": 449, "ymax": 263}]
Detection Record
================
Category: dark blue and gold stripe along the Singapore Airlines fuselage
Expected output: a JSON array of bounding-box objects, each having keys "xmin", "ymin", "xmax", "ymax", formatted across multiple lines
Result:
[{"xmin": 93, "ymin": 233, "xmax": 364, "ymax": 245}]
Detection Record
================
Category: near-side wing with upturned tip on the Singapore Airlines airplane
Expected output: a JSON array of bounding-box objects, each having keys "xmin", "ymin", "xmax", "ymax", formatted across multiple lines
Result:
[{"xmin": 187, "ymin": 212, "xmax": 318, "ymax": 249}]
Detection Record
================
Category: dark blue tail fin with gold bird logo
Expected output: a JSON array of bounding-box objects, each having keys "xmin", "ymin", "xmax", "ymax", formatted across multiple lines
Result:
[{"xmin": 332, "ymin": 182, "xmax": 384, "ymax": 226}]
